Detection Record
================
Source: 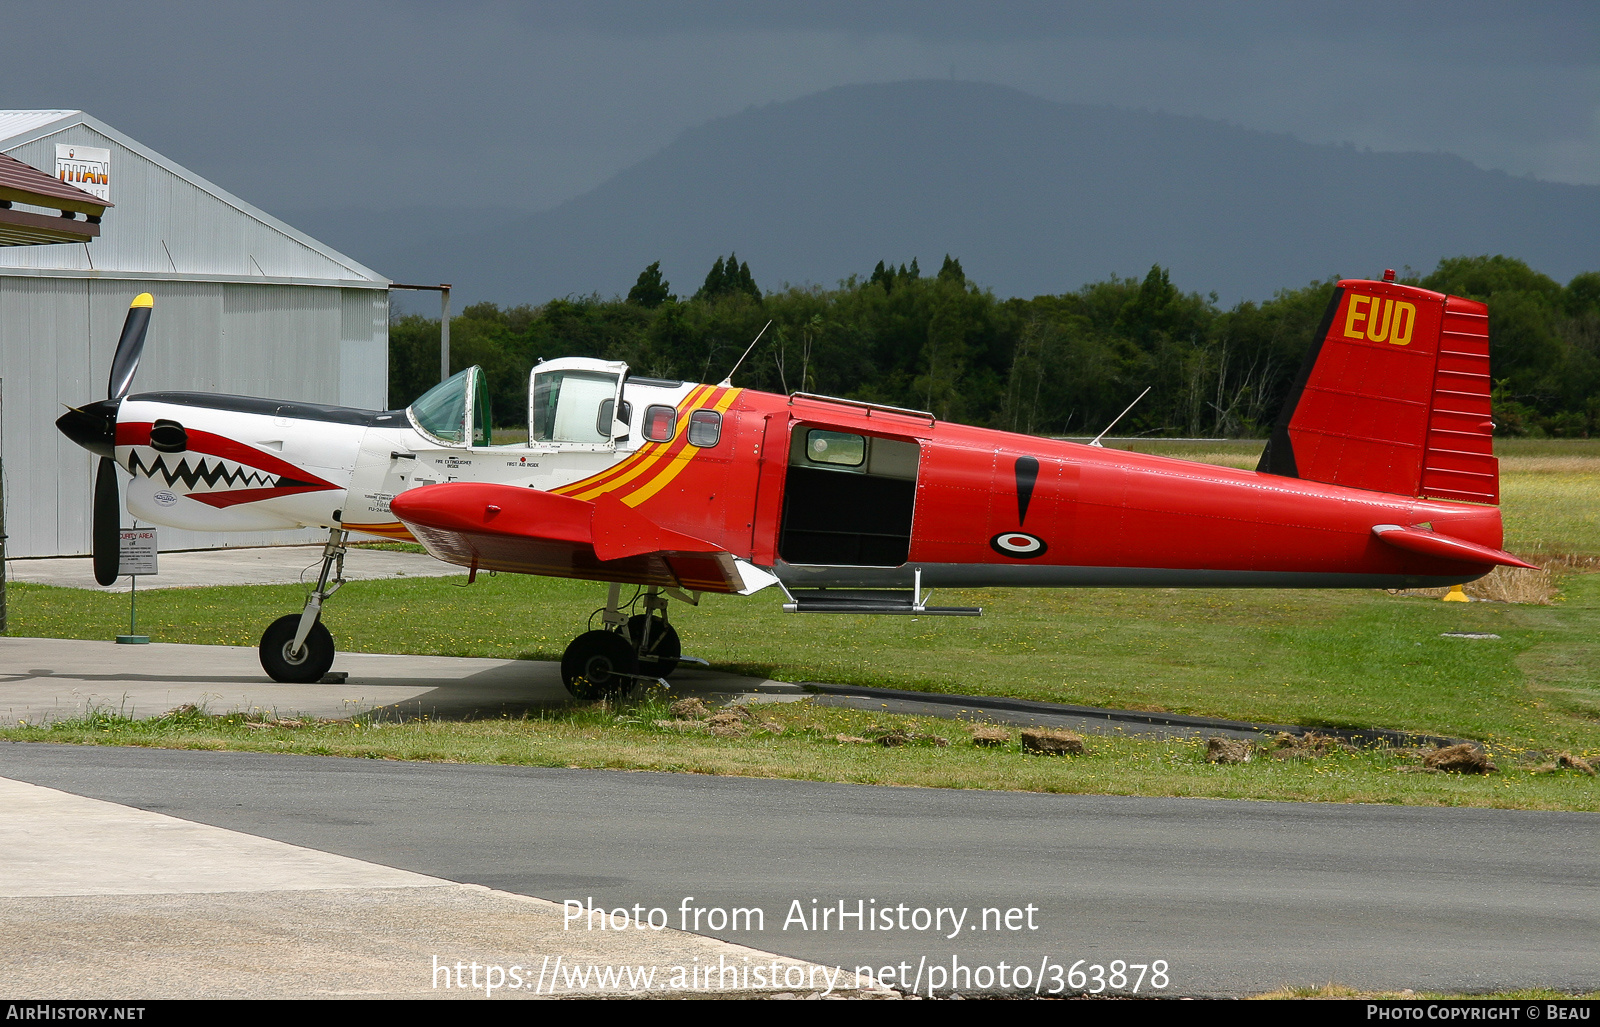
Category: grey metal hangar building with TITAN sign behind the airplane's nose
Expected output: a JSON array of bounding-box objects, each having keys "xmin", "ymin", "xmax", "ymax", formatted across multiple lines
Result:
[{"xmin": 0, "ymin": 110, "xmax": 390, "ymax": 558}]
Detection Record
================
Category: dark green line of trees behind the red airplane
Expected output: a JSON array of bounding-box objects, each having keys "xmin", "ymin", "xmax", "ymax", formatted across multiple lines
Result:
[{"xmin": 389, "ymin": 254, "xmax": 1600, "ymax": 437}]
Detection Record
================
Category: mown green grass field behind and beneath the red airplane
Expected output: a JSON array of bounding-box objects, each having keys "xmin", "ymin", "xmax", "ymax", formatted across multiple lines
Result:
[{"xmin": 10, "ymin": 431, "xmax": 1600, "ymax": 808}]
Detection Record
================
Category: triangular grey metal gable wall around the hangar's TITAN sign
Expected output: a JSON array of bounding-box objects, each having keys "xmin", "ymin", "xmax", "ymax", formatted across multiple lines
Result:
[{"xmin": 0, "ymin": 125, "xmax": 371, "ymax": 278}]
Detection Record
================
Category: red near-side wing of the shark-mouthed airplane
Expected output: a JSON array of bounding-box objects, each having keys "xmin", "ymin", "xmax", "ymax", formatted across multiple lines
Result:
[{"xmin": 389, "ymin": 482, "xmax": 744, "ymax": 592}]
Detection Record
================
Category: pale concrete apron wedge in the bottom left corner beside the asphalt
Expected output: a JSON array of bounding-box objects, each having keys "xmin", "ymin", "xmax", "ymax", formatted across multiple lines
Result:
[{"xmin": 0, "ymin": 777, "xmax": 898, "ymax": 1000}]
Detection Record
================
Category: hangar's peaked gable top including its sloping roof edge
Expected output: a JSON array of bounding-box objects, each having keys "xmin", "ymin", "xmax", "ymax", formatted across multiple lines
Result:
[{"xmin": 0, "ymin": 110, "xmax": 389, "ymax": 290}]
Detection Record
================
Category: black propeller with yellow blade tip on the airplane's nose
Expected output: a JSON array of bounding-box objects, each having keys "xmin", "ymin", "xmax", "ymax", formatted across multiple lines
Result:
[{"xmin": 56, "ymin": 293, "xmax": 155, "ymax": 585}]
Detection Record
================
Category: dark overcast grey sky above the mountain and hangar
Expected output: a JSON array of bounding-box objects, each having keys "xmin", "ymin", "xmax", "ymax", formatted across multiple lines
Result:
[{"xmin": 0, "ymin": 0, "xmax": 1600, "ymax": 211}]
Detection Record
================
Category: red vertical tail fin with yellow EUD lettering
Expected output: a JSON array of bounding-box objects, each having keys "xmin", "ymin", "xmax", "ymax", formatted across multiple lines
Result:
[{"xmin": 1256, "ymin": 280, "xmax": 1499, "ymax": 504}]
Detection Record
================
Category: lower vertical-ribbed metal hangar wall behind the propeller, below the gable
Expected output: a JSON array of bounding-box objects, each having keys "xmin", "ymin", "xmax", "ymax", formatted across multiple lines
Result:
[{"xmin": 0, "ymin": 275, "xmax": 387, "ymax": 557}]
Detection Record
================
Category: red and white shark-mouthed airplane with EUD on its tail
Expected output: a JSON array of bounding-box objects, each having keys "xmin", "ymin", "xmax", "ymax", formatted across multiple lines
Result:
[{"xmin": 58, "ymin": 272, "xmax": 1530, "ymax": 697}]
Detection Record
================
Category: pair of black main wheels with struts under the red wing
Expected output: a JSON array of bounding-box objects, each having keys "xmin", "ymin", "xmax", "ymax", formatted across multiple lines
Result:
[{"xmin": 562, "ymin": 584, "xmax": 683, "ymax": 699}]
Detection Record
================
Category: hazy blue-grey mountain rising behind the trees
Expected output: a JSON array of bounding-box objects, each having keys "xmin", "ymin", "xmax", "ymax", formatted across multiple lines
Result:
[{"xmin": 302, "ymin": 82, "xmax": 1600, "ymax": 304}]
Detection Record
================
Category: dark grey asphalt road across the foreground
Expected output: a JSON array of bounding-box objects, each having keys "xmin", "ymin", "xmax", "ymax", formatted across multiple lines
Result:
[{"xmin": 0, "ymin": 742, "xmax": 1600, "ymax": 995}]
